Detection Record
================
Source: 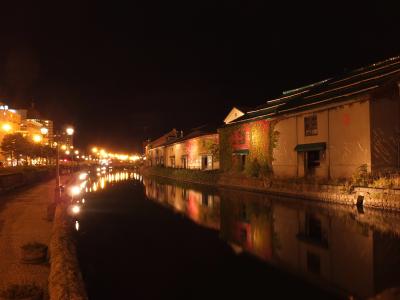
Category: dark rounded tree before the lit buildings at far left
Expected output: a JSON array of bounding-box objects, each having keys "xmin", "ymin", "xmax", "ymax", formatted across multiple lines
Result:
[{"xmin": 0, "ymin": 133, "xmax": 31, "ymax": 163}]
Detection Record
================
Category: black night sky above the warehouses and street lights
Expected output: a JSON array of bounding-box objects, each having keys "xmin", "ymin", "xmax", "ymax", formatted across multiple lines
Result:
[{"xmin": 0, "ymin": 0, "xmax": 400, "ymax": 150}]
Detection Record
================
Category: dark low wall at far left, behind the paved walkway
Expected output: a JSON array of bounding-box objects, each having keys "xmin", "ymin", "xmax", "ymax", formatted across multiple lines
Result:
[{"xmin": 0, "ymin": 167, "xmax": 55, "ymax": 195}]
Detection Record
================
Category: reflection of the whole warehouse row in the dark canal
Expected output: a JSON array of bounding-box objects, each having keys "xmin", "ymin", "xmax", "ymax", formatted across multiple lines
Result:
[{"xmin": 138, "ymin": 174, "xmax": 400, "ymax": 297}]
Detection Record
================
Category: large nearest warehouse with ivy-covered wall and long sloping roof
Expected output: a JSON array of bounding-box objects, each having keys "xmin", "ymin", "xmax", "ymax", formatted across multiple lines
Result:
[{"xmin": 220, "ymin": 57, "xmax": 400, "ymax": 178}]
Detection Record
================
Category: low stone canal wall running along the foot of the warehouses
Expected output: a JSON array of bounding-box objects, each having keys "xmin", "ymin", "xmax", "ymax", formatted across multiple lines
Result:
[{"xmin": 141, "ymin": 167, "xmax": 400, "ymax": 211}]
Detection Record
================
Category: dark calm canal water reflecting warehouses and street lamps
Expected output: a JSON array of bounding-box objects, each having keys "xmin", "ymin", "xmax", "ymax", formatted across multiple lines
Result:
[{"xmin": 75, "ymin": 171, "xmax": 400, "ymax": 299}]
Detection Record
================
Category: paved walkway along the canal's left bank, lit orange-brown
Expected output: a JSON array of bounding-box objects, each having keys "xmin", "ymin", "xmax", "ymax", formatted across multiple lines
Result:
[{"xmin": 0, "ymin": 177, "xmax": 67, "ymax": 296}]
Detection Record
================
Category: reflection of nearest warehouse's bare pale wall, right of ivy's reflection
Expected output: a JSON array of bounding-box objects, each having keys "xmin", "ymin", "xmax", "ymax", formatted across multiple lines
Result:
[{"xmin": 273, "ymin": 203, "xmax": 400, "ymax": 297}]
